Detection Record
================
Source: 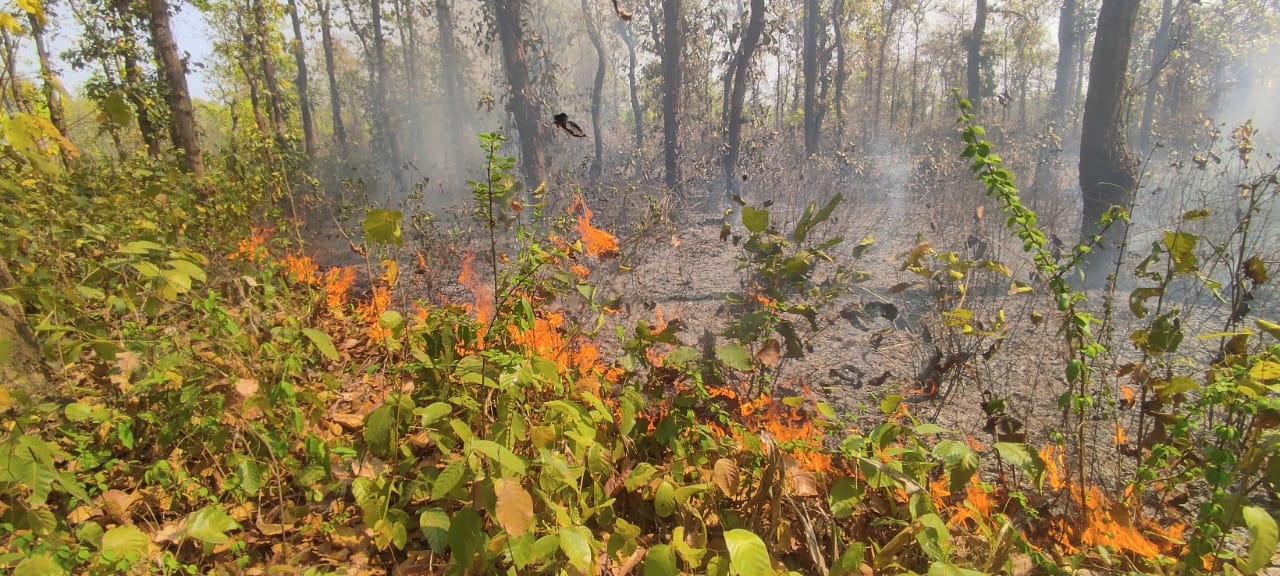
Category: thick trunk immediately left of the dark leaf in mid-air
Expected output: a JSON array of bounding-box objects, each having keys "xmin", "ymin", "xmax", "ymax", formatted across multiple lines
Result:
[{"xmin": 493, "ymin": 0, "xmax": 547, "ymax": 189}]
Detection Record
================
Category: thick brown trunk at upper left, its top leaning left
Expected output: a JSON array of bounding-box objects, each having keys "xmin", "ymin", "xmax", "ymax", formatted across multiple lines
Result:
[{"xmin": 147, "ymin": 0, "xmax": 205, "ymax": 178}]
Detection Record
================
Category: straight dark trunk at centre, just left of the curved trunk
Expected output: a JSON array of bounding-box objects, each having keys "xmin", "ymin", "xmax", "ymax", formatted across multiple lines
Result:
[{"xmin": 662, "ymin": 0, "xmax": 685, "ymax": 196}]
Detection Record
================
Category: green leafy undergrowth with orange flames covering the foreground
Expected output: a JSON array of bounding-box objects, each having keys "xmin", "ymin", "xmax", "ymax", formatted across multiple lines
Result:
[{"xmin": 0, "ymin": 122, "xmax": 1280, "ymax": 576}]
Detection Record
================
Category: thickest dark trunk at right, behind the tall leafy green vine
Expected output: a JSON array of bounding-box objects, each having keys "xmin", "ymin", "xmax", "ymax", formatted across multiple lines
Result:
[{"xmin": 1080, "ymin": 0, "xmax": 1138, "ymax": 285}]
